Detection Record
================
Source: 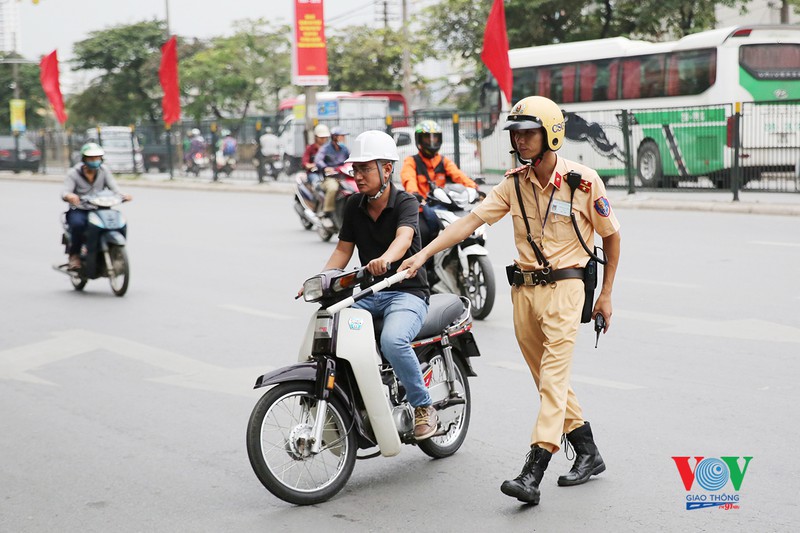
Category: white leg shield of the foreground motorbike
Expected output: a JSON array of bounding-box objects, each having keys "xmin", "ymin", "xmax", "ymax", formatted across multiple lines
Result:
[{"xmin": 336, "ymin": 307, "xmax": 400, "ymax": 457}]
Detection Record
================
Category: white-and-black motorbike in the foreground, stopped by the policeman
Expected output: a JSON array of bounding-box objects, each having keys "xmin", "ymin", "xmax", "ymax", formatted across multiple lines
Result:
[{"xmin": 247, "ymin": 268, "xmax": 480, "ymax": 505}]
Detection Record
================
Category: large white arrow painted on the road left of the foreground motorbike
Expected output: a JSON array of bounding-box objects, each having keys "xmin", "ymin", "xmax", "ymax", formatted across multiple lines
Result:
[{"xmin": 0, "ymin": 330, "xmax": 272, "ymax": 397}]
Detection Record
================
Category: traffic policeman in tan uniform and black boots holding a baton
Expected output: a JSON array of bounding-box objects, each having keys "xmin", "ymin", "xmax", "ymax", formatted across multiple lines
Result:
[{"xmin": 400, "ymin": 96, "xmax": 620, "ymax": 504}]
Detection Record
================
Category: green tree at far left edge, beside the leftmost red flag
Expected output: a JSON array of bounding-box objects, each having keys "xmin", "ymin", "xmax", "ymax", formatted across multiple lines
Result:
[{"xmin": 0, "ymin": 53, "xmax": 50, "ymax": 131}]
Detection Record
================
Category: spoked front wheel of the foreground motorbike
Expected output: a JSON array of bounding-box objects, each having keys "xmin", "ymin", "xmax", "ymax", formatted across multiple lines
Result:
[{"xmin": 247, "ymin": 382, "xmax": 358, "ymax": 505}]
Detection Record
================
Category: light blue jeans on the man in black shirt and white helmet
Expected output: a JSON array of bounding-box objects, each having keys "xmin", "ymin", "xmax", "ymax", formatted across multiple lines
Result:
[{"xmin": 353, "ymin": 291, "xmax": 431, "ymax": 407}]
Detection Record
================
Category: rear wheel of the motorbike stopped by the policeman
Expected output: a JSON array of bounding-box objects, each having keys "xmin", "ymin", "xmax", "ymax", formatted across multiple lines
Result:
[{"xmin": 418, "ymin": 354, "xmax": 472, "ymax": 459}]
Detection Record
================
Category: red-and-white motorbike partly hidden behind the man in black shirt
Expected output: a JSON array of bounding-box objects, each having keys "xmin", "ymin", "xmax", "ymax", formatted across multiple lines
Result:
[{"xmin": 294, "ymin": 163, "xmax": 358, "ymax": 241}]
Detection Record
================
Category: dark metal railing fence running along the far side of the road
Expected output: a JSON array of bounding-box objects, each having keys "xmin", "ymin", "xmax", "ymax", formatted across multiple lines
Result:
[{"xmin": 10, "ymin": 101, "xmax": 800, "ymax": 193}]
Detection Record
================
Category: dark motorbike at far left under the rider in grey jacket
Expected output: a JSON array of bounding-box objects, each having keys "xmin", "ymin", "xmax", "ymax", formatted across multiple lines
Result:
[{"xmin": 53, "ymin": 191, "xmax": 130, "ymax": 296}]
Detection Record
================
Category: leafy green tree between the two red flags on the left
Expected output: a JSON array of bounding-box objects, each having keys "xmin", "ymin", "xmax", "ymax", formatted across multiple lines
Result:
[{"xmin": 68, "ymin": 20, "xmax": 166, "ymax": 126}]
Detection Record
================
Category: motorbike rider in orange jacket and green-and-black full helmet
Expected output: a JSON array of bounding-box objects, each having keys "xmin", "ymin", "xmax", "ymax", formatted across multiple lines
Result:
[{"xmin": 400, "ymin": 120, "xmax": 478, "ymax": 246}]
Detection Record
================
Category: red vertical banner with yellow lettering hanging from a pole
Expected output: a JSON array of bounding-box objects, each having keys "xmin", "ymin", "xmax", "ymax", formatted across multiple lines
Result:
[{"xmin": 292, "ymin": 0, "xmax": 328, "ymax": 86}]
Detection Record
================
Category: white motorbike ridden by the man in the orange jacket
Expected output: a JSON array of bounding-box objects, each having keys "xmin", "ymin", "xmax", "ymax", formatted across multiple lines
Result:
[{"xmin": 426, "ymin": 183, "xmax": 495, "ymax": 320}]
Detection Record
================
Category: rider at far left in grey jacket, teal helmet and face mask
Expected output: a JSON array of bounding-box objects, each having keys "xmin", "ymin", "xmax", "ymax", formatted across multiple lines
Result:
[{"xmin": 61, "ymin": 142, "xmax": 133, "ymax": 270}]
